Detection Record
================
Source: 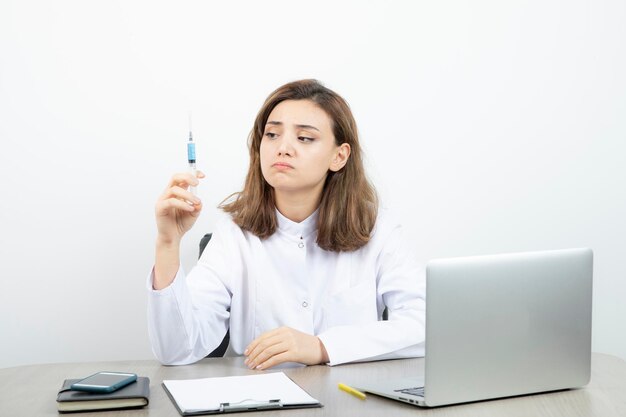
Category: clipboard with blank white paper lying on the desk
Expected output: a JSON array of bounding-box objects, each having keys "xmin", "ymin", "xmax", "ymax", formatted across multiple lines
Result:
[{"xmin": 162, "ymin": 372, "xmax": 322, "ymax": 416}]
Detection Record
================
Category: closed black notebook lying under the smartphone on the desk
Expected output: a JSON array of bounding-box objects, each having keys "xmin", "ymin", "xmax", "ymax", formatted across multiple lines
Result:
[{"xmin": 57, "ymin": 377, "xmax": 150, "ymax": 413}]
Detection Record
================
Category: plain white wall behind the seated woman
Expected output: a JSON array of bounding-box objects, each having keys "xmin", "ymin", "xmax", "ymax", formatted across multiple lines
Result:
[{"xmin": 0, "ymin": 0, "xmax": 626, "ymax": 367}]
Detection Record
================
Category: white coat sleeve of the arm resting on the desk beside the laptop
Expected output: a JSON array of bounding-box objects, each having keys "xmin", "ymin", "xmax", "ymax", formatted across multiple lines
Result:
[{"xmin": 318, "ymin": 226, "xmax": 426, "ymax": 366}]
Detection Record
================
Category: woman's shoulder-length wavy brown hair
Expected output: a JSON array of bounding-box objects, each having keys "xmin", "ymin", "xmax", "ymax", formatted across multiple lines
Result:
[{"xmin": 219, "ymin": 80, "xmax": 378, "ymax": 252}]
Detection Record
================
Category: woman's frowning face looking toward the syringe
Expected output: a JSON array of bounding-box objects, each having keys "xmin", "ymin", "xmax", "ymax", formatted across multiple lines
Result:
[{"xmin": 260, "ymin": 100, "xmax": 350, "ymax": 192}]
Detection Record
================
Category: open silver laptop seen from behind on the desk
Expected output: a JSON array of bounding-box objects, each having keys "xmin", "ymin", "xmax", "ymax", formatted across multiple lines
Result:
[{"xmin": 355, "ymin": 249, "xmax": 593, "ymax": 407}]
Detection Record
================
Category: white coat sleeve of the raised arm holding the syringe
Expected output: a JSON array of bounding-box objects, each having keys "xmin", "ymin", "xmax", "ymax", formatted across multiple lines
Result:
[{"xmin": 147, "ymin": 218, "xmax": 238, "ymax": 365}]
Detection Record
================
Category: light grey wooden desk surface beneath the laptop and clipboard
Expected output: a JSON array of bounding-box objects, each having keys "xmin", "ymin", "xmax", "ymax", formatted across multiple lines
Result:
[{"xmin": 0, "ymin": 353, "xmax": 626, "ymax": 417}]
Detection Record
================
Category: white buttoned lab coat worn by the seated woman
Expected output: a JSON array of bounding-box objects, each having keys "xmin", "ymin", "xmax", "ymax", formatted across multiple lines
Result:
[{"xmin": 148, "ymin": 209, "xmax": 426, "ymax": 365}]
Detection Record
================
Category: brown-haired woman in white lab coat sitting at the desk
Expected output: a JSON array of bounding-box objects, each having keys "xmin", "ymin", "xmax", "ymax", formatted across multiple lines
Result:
[{"xmin": 148, "ymin": 80, "xmax": 425, "ymax": 369}]
